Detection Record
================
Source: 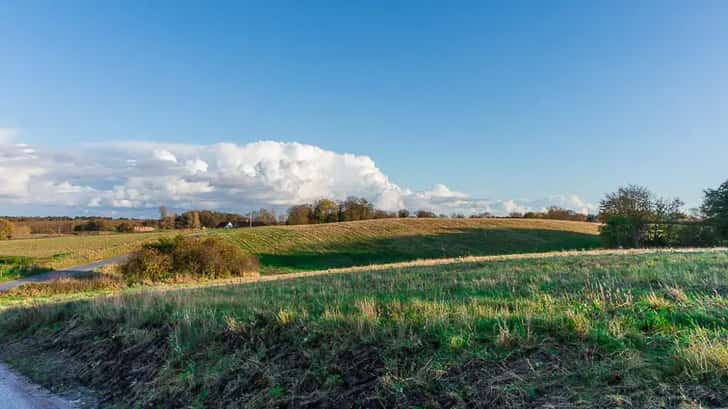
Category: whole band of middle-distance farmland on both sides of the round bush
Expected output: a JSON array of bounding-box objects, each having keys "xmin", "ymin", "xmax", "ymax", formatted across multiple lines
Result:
[{"xmin": 0, "ymin": 219, "xmax": 600, "ymax": 273}]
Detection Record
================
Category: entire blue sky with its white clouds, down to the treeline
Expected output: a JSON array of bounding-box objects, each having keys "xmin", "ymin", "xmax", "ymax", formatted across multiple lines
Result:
[{"xmin": 0, "ymin": 0, "xmax": 728, "ymax": 216}]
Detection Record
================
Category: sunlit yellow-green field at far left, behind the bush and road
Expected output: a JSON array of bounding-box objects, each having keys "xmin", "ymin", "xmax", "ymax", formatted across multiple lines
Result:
[{"xmin": 0, "ymin": 232, "xmax": 193, "ymax": 269}]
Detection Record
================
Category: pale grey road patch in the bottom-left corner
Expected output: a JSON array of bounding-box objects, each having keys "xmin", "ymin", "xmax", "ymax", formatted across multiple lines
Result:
[{"xmin": 0, "ymin": 363, "xmax": 78, "ymax": 409}]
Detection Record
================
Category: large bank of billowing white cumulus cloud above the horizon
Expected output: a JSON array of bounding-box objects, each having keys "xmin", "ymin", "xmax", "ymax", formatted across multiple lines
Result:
[{"xmin": 0, "ymin": 139, "xmax": 594, "ymax": 214}]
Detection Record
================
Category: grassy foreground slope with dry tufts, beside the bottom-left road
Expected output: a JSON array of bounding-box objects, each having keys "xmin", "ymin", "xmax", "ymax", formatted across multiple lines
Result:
[{"xmin": 0, "ymin": 252, "xmax": 728, "ymax": 408}]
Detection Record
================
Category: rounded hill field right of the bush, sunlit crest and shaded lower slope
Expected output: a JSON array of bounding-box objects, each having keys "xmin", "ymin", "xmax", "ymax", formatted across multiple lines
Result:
[{"xmin": 213, "ymin": 219, "xmax": 600, "ymax": 273}]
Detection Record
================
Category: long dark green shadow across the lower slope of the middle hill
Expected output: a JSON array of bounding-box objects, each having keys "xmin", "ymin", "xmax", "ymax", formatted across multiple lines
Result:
[{"xmin": 258, "ymin": 229, "xmax": 601, "ymax": 273}]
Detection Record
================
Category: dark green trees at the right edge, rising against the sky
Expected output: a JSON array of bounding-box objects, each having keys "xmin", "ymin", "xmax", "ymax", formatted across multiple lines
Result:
[{"xmin": 599, "ymin": 181, "xmax": 728, "ymax": 247}]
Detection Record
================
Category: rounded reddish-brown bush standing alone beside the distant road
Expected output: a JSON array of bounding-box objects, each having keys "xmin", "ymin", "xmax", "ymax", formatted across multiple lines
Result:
[{"xmin": 121, "ymin": 236, "xmax": 259, "ymax": 284}]
